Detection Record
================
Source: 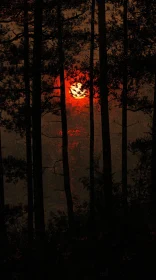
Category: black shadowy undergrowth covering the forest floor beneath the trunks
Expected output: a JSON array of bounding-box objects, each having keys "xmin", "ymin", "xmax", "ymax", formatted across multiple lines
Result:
[{"xmin": 1, "ymin": 198, "xmax": 156, "ymax": 280}]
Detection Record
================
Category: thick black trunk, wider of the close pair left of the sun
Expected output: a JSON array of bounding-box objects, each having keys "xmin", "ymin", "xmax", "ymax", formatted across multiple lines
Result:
[{"xmin": 32, "ymin": 0, "xmax": 45, "ymax": 240}]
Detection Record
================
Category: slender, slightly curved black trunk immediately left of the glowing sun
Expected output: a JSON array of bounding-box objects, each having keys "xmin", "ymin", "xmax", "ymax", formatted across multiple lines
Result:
[{"xmin": 57, "ymin": 2, "xmax": 74, "ymax": 228}]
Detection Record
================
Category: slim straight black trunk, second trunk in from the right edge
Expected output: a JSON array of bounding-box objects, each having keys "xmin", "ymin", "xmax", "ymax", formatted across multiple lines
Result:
[{"xmin": 122, "ymin": 0, "xmax": 128, "ymax": 213}]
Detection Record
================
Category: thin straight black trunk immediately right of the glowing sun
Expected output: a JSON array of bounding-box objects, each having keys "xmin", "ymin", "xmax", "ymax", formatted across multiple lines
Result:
[{"xmin": 90, "ymin": 0, "xmax": 95, "ymax": 227}]
